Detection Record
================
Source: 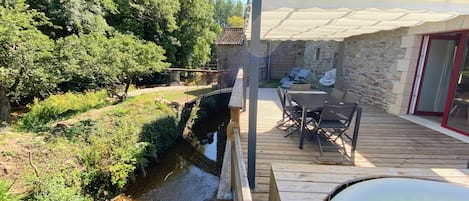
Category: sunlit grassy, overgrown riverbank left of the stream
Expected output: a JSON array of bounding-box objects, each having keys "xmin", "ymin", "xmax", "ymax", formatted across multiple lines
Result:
[{"xmin": 0, "ymin": 87, "xmax": 212, "ymax": 200}]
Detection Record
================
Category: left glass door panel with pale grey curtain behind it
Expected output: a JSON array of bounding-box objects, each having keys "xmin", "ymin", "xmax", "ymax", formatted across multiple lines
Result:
[{"xmin": 414, "ymin": 34, "xmax": 460, "ymax": 116}]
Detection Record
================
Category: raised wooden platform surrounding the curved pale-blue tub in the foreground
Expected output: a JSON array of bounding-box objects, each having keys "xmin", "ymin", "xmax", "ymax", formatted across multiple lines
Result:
[{"xmin": 269, "ymin": 163, "xmax": 469, "ymax": 201}]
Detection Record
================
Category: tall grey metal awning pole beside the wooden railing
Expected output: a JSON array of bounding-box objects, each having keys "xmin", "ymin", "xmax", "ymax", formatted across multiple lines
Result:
[{"xmin": 248, "ymin": 0, "xmax": 262, "ymax": 189}]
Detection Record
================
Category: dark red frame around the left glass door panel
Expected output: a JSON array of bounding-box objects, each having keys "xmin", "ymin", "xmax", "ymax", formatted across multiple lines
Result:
[{"xmin": 412, "ymin": 33, "xmax": 462, "ymax": 116}]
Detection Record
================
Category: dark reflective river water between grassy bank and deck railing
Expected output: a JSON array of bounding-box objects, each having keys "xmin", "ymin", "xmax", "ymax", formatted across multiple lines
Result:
[{"xmin": 125, "ymin": 100, "xmax": 228, "ymax": 201}]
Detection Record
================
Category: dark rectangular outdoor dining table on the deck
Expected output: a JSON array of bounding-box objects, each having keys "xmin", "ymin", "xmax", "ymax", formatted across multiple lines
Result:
[{"xmin": 287, "ymin": 91, "xmax": 327, "ymax": 149}]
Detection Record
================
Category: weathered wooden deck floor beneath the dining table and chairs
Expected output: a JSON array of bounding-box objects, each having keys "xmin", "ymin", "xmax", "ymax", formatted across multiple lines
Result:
[{"xmin": 240, "ymin": 89, "xmax": 469, "ymax": 200}]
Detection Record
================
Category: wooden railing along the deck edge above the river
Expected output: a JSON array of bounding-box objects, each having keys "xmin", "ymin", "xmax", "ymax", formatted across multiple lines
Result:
[{"xmin": 217, "ymin": 69, "xmax": 252, "ymax": 201}]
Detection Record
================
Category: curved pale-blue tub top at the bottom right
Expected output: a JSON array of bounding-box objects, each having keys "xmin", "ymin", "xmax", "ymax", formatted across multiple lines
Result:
[{"xmin": 332, "ymin": 178, "xmax": 469, "ymax": 201}]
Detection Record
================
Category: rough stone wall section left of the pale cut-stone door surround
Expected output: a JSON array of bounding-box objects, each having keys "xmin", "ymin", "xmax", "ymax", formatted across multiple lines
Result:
[{"xmin": 343, "ymin": 28, "xmax": 408, "ymax": 111}]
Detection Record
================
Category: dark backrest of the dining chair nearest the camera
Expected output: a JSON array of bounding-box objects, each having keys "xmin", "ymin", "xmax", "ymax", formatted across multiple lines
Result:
[{"xmin": 319, "ymin": 103, "xmax": 357, "ymax": 127}]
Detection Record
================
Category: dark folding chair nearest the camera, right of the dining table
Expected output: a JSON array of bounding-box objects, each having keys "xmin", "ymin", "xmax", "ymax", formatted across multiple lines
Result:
[{"xmin": 312, "ymin": 102, "xmax": 358, "ymax": 155}]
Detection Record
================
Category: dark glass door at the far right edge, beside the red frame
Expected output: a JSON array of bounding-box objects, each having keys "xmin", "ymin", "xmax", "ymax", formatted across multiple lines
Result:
[{"xmin": 443, "ymin": 32, "xmax": 469, "ymax": 135}]
